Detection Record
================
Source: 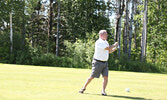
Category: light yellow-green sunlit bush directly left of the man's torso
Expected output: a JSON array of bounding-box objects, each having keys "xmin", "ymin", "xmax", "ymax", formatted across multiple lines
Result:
[{"xmin": 64, "ymin": 33, "xmax": 97, "ymax": 68}]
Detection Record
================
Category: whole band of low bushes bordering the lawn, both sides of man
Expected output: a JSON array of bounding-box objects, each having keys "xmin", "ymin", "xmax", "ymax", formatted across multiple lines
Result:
[{"xmin": 0, "ymin": 33, "xmax": 164, "ymax": 72}]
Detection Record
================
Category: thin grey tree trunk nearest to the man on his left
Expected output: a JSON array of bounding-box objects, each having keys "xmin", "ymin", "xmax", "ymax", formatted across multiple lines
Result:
[{"xmin": 56, "ymin": 1, "xmax": 60, "ymax": 56}]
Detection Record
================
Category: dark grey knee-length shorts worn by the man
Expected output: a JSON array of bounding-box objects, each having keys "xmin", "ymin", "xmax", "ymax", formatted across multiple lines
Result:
[{"xmin": 91, "ymin": 60, "xmax": 108, "ymax": 78}]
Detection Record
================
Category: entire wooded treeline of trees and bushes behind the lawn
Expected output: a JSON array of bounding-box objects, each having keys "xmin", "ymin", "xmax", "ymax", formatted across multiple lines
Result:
[{"xmin": 0, "ymin": 0, "xmax": 167, "ymax": 72}]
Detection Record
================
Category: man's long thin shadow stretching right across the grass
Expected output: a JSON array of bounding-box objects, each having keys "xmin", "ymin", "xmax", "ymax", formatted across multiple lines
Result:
[{"xmin": 84, "ymin": 93, "xmax": 152, "ymax": 100}]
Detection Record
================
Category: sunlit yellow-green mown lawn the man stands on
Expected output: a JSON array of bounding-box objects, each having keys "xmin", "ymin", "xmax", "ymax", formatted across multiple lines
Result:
[{"xmin": 0, "ymin": 64, "xmax": 167, "ymax": 100}]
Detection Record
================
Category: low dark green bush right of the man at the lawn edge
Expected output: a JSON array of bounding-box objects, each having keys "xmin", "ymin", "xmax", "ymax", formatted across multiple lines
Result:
[{"xmin": 109, "ymin": 55, "xmax": 160, "ymax": 72}]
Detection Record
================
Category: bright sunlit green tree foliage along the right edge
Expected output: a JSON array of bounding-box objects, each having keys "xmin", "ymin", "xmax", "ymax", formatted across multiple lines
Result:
[{"xmin": 147, "ymin": 0, "xmax": 167, "ymax": 68}]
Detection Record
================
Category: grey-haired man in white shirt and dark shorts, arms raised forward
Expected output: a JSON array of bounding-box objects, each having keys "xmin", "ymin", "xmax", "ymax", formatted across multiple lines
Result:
[{"xmin": 79, "ymin": 30, "xmax": 118, "ymax": 96}]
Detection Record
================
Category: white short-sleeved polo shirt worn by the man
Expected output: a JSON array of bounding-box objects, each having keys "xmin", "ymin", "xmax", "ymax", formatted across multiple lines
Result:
[{"xmin": 93, "ymin": 38, "xmax": 109, "ymax": 61}]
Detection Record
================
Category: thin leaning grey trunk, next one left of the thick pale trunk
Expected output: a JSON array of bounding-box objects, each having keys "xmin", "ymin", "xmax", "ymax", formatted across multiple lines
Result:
[{"xmin": 128, "ymin": 0, "xmax": 135, "ymax": 59}]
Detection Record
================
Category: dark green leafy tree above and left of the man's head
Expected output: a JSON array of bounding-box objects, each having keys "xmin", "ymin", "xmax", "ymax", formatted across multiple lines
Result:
[{"xmin": 54, "ymin": 0, "xmax": 111, "ymax": 56}]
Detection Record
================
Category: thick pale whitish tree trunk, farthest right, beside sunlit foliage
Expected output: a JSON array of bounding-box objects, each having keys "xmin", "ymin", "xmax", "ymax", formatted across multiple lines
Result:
[{"xmin": 141, "ymin": 0, "xmax": 147, "ymax": 61}]
